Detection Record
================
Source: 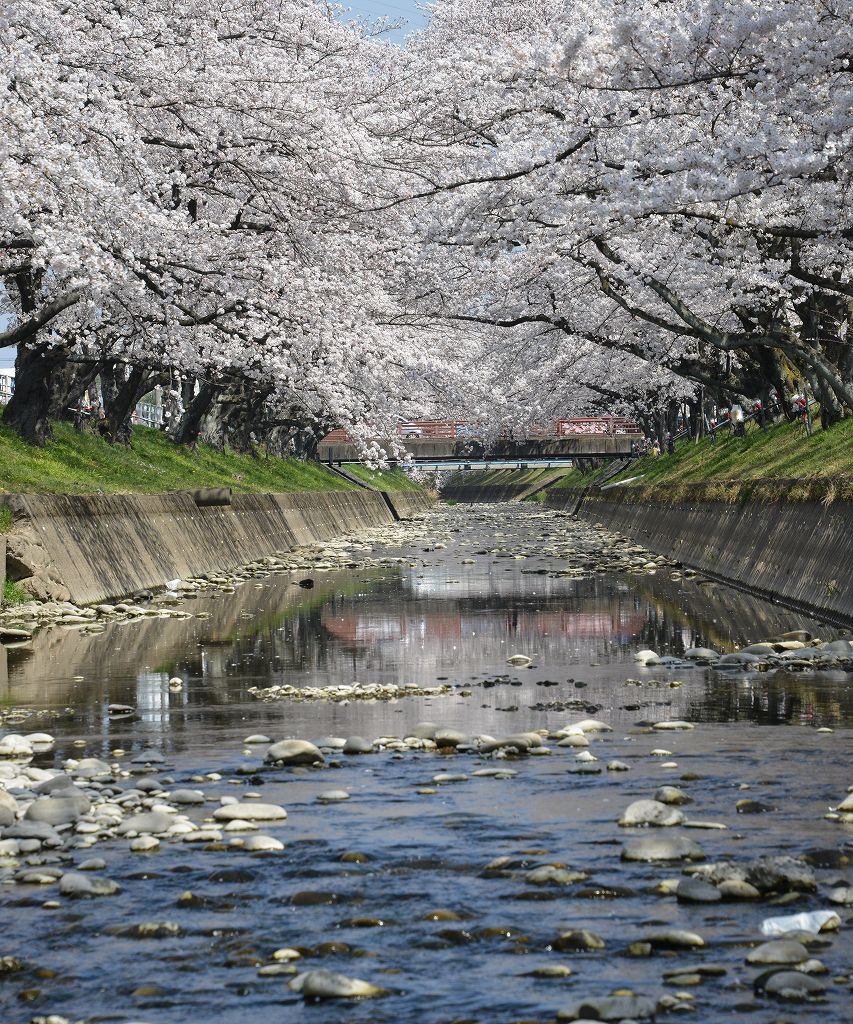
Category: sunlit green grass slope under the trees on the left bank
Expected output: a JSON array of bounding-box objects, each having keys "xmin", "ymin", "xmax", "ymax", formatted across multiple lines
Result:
[{"xmin": 0, "ymin": 423, "xmax": 356, "ymax": 493}]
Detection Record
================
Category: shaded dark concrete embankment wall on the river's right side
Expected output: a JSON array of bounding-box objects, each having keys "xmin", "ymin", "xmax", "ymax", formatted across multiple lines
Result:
[{"xmin": 547, "ymin": 487, "xmax": 853, "ymax": 622}]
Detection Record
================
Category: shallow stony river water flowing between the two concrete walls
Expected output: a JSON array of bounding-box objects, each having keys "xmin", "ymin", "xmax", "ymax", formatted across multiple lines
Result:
[{"xmin": 0, "ymin": 505, "xmax": 853, "ymax": 1024}]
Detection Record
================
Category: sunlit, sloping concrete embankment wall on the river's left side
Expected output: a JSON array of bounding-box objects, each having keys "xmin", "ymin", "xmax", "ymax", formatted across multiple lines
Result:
[{"xmin": 2, "ymin": 489, "xmax": 429, "ymax": 604}]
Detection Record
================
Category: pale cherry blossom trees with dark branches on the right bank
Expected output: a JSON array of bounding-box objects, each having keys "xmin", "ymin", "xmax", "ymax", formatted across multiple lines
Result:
[{"xmin": 384, "ymin": 0, "xmax": 853, "ymax": 421}]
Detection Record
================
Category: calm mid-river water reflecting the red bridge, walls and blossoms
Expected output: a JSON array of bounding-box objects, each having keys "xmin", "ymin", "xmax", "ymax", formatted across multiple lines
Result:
[{"xmin": 2, "ymin": 536, "xmax": 853, "ymax": 761}]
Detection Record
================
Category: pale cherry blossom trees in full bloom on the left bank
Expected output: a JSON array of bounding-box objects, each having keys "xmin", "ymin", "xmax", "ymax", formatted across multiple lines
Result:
[{"xmin": 0, "ymin": 0, "xmax": 432, "ymax": 441}]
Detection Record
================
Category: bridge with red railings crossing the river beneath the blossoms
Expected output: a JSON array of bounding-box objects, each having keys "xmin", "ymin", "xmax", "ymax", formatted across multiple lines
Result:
[{"xmin": 317, "ymin": 416, "xmax": 642, "ymax": 468}]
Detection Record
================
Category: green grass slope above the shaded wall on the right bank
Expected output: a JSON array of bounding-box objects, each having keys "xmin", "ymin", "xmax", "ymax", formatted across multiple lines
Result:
[{"xmin": 608, "ymin": 411, "xmax": 853, "ymax": 486}]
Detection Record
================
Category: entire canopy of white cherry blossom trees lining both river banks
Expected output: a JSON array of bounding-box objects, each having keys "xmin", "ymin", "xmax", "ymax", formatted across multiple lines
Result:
[{"xmin": 0, "ymin": 0, "xmax": 853, "ymax": 454}]
